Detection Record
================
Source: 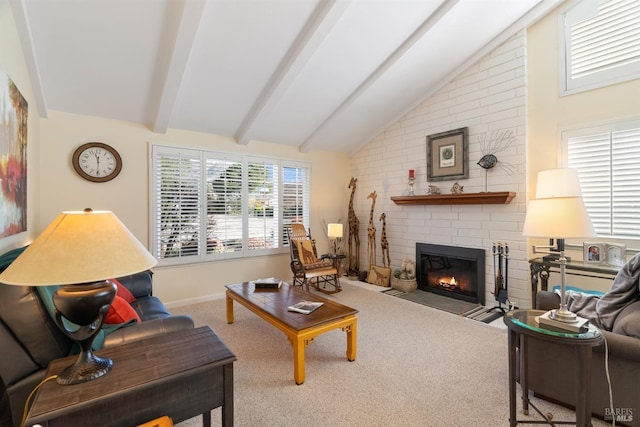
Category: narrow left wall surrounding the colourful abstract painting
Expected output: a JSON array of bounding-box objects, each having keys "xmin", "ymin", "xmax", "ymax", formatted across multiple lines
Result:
[{"xmin": 0, "ymin": 0, "xmax": 40, "ymax": 253}]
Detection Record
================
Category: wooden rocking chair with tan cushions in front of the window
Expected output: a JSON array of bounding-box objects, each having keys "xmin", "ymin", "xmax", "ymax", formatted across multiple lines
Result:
[{"xmin": 287, "ymin": 224, "xmax": 342, "ymax": 294}]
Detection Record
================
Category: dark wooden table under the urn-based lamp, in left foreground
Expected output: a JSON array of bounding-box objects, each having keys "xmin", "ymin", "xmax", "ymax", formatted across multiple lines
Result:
[{"xmin": 25, "ymin": 326, "xmax": 236, "ymax": 427}]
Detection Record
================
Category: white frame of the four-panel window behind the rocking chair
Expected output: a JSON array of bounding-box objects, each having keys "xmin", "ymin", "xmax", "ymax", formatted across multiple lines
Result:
[{"xmin": 149, "ymin": 142, "xmax": 312, "ymax": 266}]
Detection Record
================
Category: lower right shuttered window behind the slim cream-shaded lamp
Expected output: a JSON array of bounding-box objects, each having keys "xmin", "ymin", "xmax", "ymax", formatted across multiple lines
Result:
[{"xmin": 562, "ymin": 121, "xmax": 640, "ymax": 239}]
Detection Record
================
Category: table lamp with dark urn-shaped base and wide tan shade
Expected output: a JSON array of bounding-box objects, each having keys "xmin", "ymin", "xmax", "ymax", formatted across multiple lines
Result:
[{"xmin": 0, "ymin": 209, "xmax": 157, "ymax": 384}]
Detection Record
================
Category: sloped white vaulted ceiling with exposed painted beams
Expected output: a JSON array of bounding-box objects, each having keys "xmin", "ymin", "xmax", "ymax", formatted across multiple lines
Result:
[{"xmin": 11, "ymin": 0, "xmax": 562, "ymax": 154}]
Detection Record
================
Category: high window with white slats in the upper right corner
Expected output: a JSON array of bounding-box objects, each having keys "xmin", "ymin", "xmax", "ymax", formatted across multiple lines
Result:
[{"xmin": 558, "ymin": 0, "xmax": 640, "ymax": 94}]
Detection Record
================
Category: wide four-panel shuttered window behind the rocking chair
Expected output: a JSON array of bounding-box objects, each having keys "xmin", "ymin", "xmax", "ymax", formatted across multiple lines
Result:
[{"xmin": 150, "ymin": 145, "xmax": 310, "ymax": 265}]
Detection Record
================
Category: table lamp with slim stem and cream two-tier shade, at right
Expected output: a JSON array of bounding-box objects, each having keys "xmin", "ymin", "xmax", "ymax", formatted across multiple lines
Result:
[{"xmin": 522, "ymin": 168, "xmax": 595, "ymax": 332}]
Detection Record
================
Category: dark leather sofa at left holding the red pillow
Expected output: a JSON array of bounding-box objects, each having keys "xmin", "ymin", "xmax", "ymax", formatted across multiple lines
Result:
[{"xmin": 0, "ymin": 271, "xmax": 193, "ymax": 427}]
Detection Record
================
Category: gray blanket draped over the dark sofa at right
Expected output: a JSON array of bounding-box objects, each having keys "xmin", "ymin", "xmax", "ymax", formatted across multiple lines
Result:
[{"xmin": 566, "ymin": 253, "xmax": 640, "ymax": 331}]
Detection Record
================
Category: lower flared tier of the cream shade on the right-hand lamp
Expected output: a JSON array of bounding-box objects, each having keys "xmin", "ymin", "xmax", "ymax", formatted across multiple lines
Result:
[{"xmin": 522, "ymin": 197, "xmax": 596, "ymax": 239}]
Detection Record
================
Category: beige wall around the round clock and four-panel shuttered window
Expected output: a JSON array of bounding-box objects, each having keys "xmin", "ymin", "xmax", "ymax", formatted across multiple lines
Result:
[{"xmin": 37, "ymin": 111, "xmax": 351, "ymax": 303}]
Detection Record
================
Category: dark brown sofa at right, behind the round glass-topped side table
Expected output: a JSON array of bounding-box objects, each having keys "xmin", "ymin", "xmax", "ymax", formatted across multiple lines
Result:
[{"xmin": 527, "ymin": 291, "xmax": 640, "ymax": 427}]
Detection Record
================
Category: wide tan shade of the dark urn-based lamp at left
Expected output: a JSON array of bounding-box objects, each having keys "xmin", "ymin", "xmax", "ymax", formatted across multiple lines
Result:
[{"xmin": 0, "ymin": 209, "xmax": 157, "ymax": 286}]
